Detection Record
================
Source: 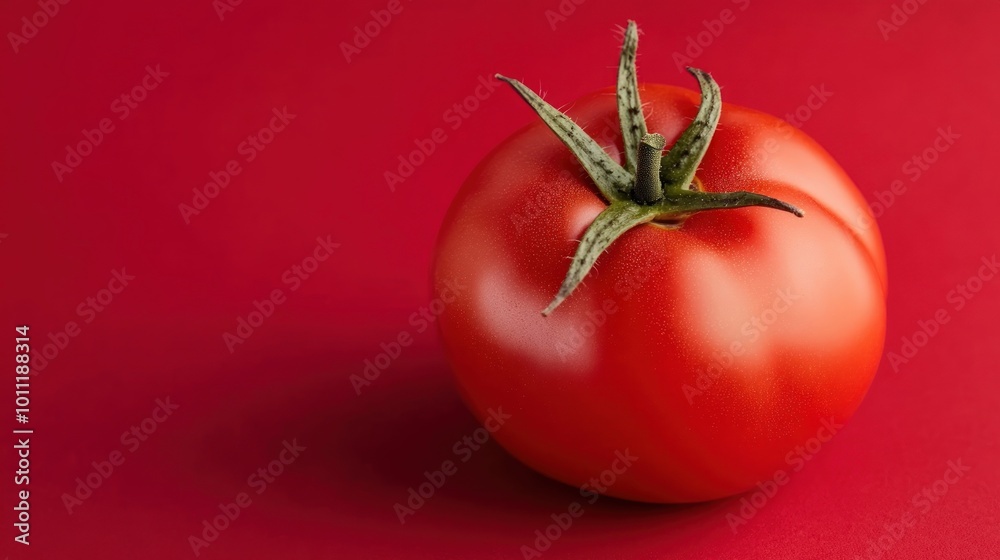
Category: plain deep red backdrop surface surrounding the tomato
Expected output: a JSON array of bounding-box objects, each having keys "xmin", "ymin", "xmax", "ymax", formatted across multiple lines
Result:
[{"xmin": 0, "ymin": 0, "xmax": 1000, "ymax": 559}]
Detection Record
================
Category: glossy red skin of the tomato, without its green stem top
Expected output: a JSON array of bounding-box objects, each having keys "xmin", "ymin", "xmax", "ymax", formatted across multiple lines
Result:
[{"xmin": 434, "ymin": 85, "xmax": 886, "ymax": 503}]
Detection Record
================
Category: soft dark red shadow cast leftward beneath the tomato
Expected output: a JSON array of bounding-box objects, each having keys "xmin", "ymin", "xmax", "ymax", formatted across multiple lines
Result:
[{"xmin": 176, "ymin": 342, "xmax": 731, "ymax": 553}]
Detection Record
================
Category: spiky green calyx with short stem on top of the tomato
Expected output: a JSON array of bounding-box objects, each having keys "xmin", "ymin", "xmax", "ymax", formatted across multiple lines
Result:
[{"xmin": 496, "ymin": 21, "xmax": 803, "ymax": 315}]
